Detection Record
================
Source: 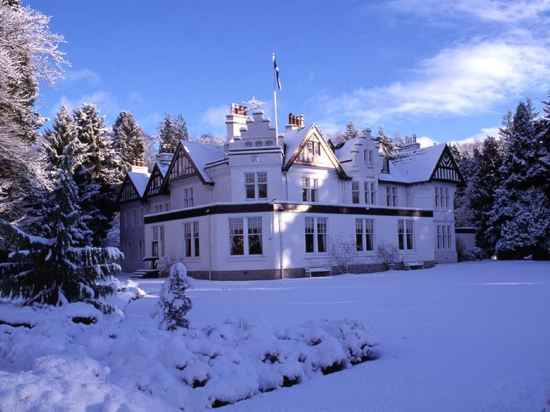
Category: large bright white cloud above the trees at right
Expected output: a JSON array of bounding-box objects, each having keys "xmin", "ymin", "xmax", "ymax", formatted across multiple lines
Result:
[{"xmin": 320, "ymin": 34, "xmax": 550, "ymax": 124}]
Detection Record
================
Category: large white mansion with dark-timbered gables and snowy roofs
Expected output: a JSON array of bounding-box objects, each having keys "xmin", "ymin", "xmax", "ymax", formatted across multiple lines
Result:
[{"xmin": 119, "ymin": 104, "xmax": 462, "ymax": 280}]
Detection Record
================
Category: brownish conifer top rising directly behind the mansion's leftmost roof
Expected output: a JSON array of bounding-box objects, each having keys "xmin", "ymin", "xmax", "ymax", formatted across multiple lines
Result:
[{"xmin": 112, "ymin": 112, "xmax": 145, "ymax": 175}]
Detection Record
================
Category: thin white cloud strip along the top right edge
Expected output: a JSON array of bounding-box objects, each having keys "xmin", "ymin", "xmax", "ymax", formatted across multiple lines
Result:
[{"xmin": 388, "ymin": 0, "xmax": 550, "ymax": 23}]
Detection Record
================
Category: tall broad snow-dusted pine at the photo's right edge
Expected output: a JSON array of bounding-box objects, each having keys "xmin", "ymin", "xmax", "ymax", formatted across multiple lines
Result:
[{"xmin": 489, "ymin": 101, "xmax": 550, "ymax": 259}]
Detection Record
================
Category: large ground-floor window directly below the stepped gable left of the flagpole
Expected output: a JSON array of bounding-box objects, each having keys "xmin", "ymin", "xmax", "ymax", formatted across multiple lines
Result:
[{"xmin": 229, "ymin": 217, "xmax": 263, "ymax": 256}]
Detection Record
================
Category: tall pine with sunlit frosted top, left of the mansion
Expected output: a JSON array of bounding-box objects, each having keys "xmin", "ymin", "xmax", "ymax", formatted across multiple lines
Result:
[{"xmin": 73, "ymin": 104, "xmax": 121, "ymax": 246}]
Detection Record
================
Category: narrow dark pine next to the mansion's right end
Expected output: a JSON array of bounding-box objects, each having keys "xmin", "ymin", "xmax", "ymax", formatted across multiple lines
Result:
[{"xmin": 472, "ymin": 136, "xmax": 502, "ymax": 256}]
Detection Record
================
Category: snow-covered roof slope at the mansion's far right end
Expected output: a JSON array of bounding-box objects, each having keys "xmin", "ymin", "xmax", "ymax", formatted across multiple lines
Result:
[{"xmin": 379, "ymin": 144, "xmax": 446, "ymax": 183}]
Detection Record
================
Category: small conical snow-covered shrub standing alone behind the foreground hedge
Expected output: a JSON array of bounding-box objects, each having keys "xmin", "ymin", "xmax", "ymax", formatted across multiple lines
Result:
[{"xmin": 159, "ymin": 262, "xmax": 191, "ymax": 330}]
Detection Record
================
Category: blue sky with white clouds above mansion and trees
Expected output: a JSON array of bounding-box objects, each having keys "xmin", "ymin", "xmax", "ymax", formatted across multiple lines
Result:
[{"xmin": 31, "ymin": 0, "xmax": 550, "ymax": 142}]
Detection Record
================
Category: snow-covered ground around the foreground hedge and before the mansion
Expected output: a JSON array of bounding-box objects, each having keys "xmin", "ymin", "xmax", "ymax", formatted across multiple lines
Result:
[{"xmin": 0, "ymin": 261, "xmax": 550, "ymax": 412}]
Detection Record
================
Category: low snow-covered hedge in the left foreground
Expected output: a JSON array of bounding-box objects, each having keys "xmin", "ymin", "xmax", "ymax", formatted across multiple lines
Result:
[{"xmin": 0, "ymin": 285, "xmax": 372, "ymax": 410}]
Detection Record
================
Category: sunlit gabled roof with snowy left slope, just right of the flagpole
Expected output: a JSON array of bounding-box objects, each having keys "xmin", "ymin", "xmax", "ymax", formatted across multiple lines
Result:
[{"xmin": 283, "ymin": 123, "xmax": 349, "ymax": 179}]
